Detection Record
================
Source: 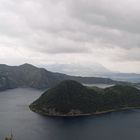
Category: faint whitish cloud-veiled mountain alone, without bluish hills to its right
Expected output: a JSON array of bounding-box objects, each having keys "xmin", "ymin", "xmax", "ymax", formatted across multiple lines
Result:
[{"xmin": 46, "ymin": 63, "xmax": 111, "ymax": 77}]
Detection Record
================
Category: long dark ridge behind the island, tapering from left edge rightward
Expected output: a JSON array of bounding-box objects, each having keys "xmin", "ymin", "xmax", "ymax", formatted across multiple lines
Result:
[{"xmin": 0, "ymin": 64, "xmax": 126, "ymax": 90}]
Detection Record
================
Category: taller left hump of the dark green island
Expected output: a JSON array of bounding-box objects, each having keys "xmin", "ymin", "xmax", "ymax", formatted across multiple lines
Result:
[{"xmin": 30, "ymin": 80, "xmax": 97, "ymax": 115}]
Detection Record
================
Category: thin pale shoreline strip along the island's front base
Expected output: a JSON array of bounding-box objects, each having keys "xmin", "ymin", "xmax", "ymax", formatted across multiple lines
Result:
[{"xmin": 29, "ymin": 107, "xmax": 140, "ymax": 117}]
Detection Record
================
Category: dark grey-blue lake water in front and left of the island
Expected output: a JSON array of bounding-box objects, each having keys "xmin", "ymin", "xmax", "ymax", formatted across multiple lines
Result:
[{"xmin": 0, "ymin": 89, "xmax": 140, "ymax": 140}]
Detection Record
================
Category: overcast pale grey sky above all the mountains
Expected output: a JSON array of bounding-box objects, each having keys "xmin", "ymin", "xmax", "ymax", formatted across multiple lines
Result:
[{"xmin": 0, "ymin": 0, "xmax": 140, "ymax": 73}]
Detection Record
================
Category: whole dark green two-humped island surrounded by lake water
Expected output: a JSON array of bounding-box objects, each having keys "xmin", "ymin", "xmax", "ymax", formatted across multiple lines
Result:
[{"xmin": 29, "ymin": 80, "xmax": 140, "ymax": 116}]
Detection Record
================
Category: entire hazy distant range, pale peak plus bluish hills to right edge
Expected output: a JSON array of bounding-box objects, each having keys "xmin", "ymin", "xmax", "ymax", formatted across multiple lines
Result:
[{"xmin": 46, "ymin": 63, "xmax": 140, "ymax": 83}]
